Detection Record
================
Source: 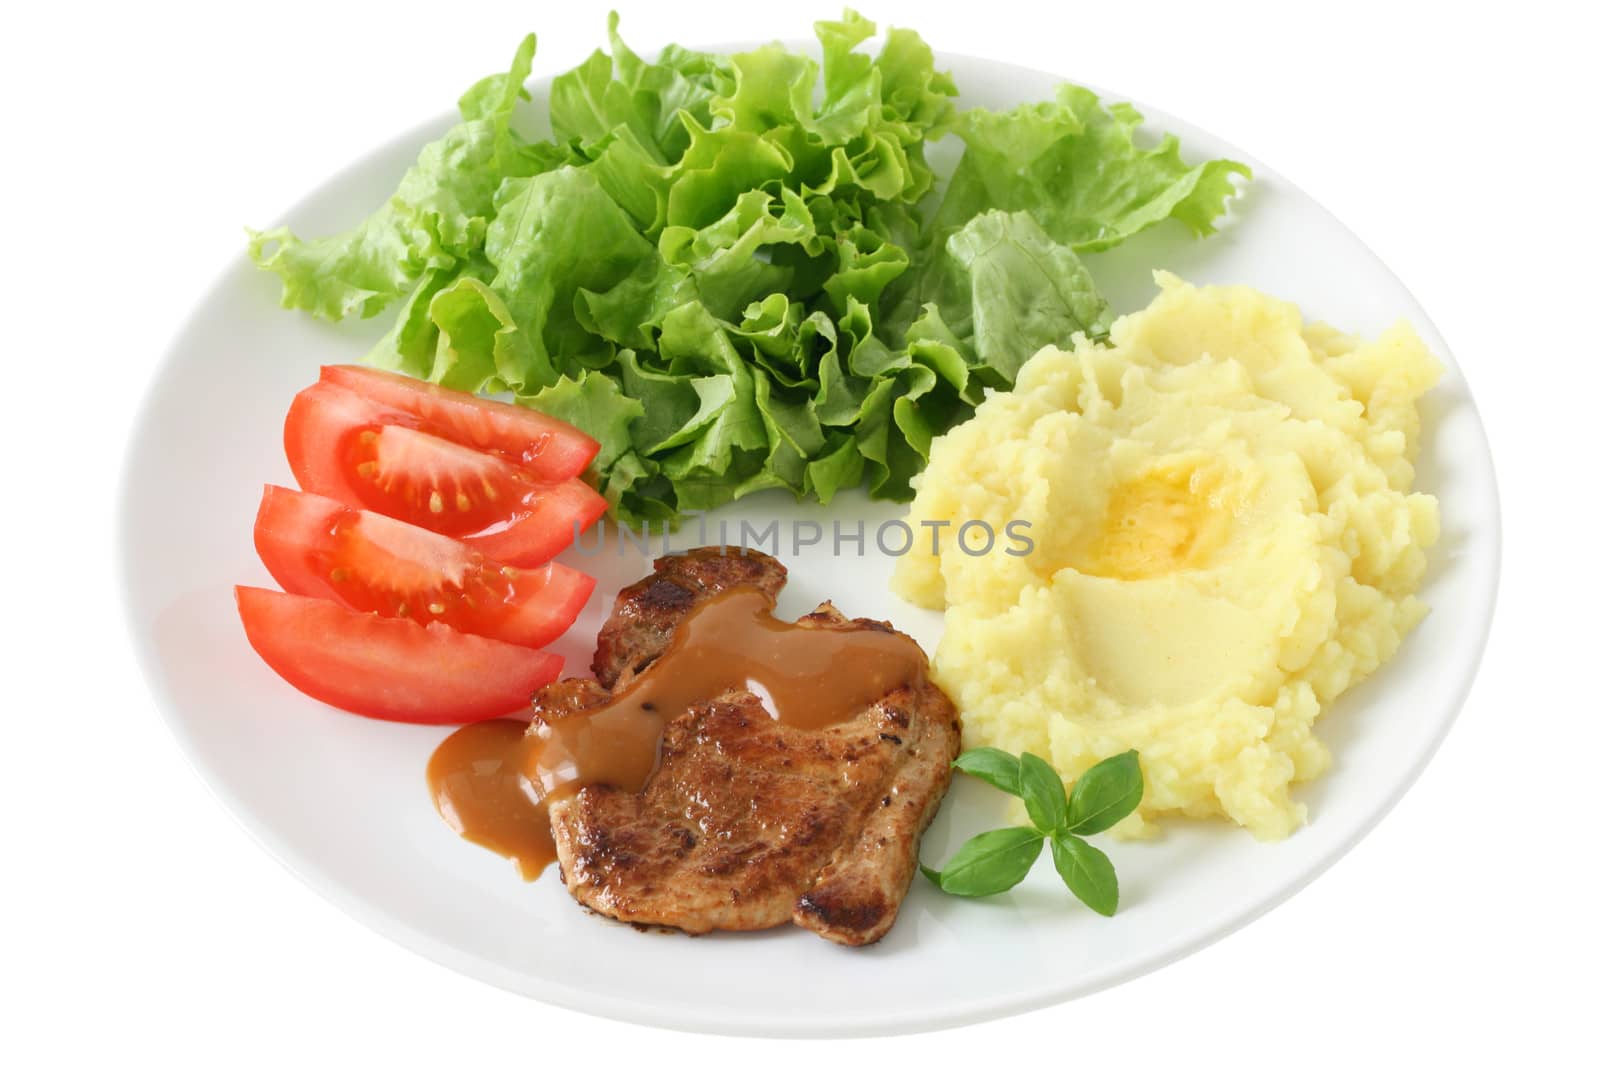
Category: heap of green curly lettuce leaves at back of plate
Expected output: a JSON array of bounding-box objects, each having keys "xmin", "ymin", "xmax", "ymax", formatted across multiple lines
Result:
[{"xmin": 250, "ymin": 11, "xmax": 1248, "ymax": 525}]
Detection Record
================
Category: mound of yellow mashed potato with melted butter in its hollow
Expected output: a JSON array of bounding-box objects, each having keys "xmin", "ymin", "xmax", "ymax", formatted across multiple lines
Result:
[{"xmin": 894, "ymin": 274, "xmax": 1440, "ymax": 838}]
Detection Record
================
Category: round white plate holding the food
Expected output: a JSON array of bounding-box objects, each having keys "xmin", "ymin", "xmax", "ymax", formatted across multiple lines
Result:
[{"xmin": 123, "ymin": 43, "xmax": 1499, "ymax": 1037}]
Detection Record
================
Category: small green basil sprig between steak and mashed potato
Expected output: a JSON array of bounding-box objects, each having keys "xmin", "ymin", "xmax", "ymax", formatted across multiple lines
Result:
[{"xmin": 922, "ymin": 749, "xmax": 1144, "ymax": 915}]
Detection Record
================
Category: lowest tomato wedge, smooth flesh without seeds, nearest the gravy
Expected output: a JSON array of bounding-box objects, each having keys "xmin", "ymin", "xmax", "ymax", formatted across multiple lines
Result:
[{"xmin": 234, "ymin": 585, "xmax": 562, "ymax": 723}]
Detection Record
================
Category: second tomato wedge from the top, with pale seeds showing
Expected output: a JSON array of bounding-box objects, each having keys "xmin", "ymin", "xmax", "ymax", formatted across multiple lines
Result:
[{"xmin": 283, "ymin": 382, "xmax": 605, "ymax": 566}]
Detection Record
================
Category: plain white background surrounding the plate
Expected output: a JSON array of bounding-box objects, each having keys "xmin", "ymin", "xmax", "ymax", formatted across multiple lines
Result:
[{"xmin": 0, "ymin": 0, "xmax": 1600, "ymax": 1064}]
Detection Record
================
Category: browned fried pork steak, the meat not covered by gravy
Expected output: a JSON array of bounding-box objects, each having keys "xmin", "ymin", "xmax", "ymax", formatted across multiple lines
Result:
[{"xmin": 534, "ymin": 549, "xmax": 960, "ymax": 945}]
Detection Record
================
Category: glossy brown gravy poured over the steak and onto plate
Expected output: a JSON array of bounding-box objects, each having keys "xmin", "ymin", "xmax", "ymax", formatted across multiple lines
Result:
[{"xmin": 427, "ymin": 589, "xmax": 928, "ymax": 880}]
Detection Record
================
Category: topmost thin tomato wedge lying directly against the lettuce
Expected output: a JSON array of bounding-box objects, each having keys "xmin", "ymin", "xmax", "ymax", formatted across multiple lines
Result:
[{"xmin": 322, "ymin": 363, "xmax": 600, "ymax": 482}]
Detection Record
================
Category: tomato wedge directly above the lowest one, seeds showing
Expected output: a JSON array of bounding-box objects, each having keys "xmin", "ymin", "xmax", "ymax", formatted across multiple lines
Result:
[{"xmin": 256, "ymin": 485, "xmax": 595, "ymax": 648}]
